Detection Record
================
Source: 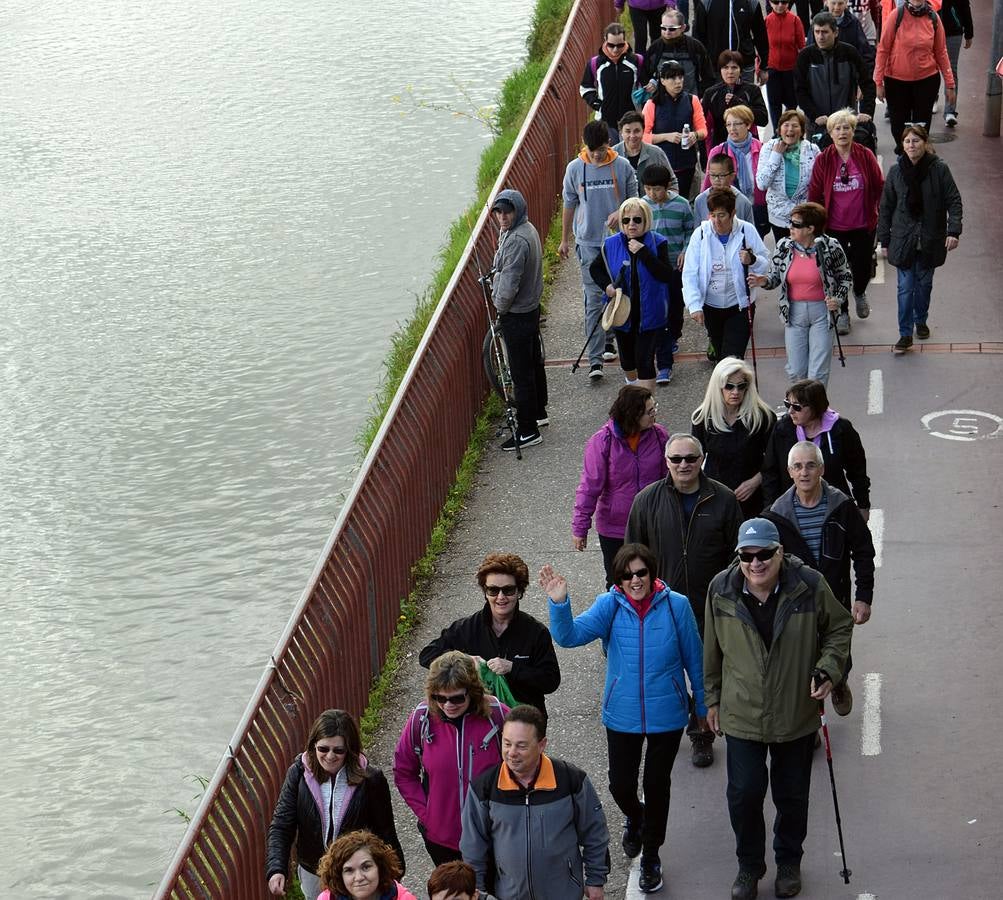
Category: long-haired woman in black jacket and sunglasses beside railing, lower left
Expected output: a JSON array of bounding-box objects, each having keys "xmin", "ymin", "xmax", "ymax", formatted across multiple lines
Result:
[{"xmin": 265, "ymin": 709, "xmax": 404, "ymax": 900}]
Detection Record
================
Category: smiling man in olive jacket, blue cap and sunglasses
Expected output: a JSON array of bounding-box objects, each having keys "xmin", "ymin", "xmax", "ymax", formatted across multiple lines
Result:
[{"xmin": 703, "ymin": 519, "xmax": 854, "ymax": 900}]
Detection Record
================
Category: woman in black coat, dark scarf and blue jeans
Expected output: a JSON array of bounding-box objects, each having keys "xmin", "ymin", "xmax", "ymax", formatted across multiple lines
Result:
[{"xmin": 878, "ymin": 125, "xmax": 962, "ymax": 353}]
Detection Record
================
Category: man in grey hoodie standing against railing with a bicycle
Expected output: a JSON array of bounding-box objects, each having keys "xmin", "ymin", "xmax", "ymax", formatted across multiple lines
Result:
[{"xmin": 491, "ymin": 191, "xmax": 547, "ymax": 451}]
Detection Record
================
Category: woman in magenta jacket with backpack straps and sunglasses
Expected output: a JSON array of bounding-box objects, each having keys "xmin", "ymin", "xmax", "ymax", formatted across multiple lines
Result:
[{"xmin": 393, "ymin": 650, "xmax": 509, "ymax": 865}]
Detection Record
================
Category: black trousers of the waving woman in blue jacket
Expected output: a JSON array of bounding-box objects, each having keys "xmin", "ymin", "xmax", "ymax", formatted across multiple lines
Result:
[{"xmin": 606, "ymin": 728, "xmax": 683, "ymax": 858}]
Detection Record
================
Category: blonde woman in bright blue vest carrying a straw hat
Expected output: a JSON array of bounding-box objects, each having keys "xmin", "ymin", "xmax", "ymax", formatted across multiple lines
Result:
[{"xmin": 589, "ymin": 197, "xmax": 672, "ymax": 390}]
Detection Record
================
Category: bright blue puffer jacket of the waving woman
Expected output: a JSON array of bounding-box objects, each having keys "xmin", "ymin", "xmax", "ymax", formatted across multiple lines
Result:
[{"xmin": 549, "ymin": 579, "xmax": 707, "ymax": 734}]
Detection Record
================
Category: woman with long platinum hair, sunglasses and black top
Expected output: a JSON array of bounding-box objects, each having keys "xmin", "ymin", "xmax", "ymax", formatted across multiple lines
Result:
[{"xmin": 692, "ymin": 356, "xmax": 776, "ymax": 519}]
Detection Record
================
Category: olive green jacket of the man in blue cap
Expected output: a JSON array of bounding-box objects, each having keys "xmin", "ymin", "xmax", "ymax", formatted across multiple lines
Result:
[{"xmin": 703, "ymin": 554, "xmax": 854, "ymax": 743}]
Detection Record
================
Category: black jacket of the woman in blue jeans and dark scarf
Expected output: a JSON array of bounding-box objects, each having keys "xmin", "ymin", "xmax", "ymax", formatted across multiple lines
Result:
[{"xmin": 878, "ymin": 157, "xmax": 962, "ymax": 269}]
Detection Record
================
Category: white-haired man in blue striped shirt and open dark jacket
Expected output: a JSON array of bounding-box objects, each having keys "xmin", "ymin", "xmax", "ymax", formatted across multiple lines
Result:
[{"xmin": 763, "ymin": 440, "xmax": 875, "ymax": 715}]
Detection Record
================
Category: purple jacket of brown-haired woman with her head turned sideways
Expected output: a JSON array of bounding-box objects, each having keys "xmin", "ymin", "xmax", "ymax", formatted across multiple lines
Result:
[{"xmin": 571, "ymin": 418, "xmax": 669, "ymax": 539}]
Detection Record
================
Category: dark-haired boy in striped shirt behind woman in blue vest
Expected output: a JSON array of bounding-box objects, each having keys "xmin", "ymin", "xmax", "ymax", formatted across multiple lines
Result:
[{"xmin": 641, "ymin": 166, "xmax": 695, "ymax": 384}]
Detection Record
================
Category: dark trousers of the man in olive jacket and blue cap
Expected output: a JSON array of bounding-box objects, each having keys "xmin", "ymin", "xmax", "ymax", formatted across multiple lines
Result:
[{"xmin": 727, "ymin": 731, "xmax": 815, "ymax": 870}]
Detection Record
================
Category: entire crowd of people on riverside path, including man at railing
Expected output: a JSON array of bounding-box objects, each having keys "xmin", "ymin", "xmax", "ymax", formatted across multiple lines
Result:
[{"xmin": 256, "ymin": 0, "xmax": 972, "ymax": 900}]
